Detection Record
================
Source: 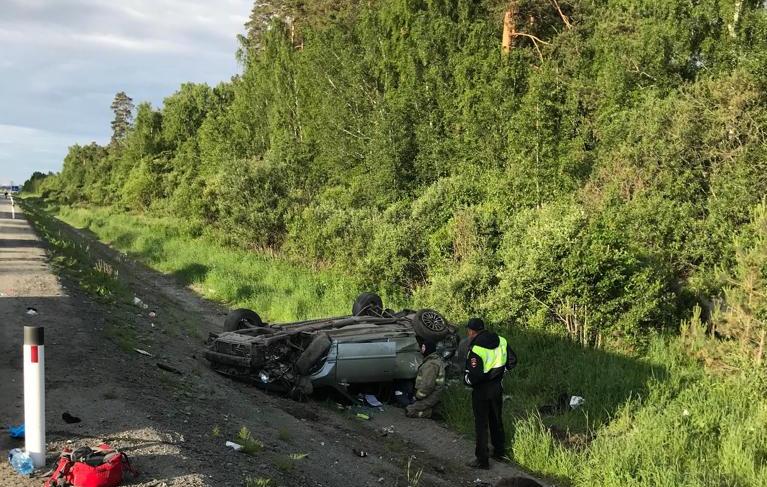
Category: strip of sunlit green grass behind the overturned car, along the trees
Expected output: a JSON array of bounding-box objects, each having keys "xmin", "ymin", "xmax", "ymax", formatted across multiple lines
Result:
[{"xmin": 48, "ymin": 203, "xmax": 366, "ymax": 322}]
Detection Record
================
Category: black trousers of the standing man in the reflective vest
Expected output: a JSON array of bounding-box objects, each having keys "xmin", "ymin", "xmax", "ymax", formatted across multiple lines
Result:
[{"xmin": 471, "ymin": 387, "xmax": 506, "ymax": 463}]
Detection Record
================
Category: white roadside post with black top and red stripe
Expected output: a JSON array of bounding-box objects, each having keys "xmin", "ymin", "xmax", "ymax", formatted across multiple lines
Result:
[{"xmin": 24, "ymin": 326, "xmax": 45, "ymax": 467}]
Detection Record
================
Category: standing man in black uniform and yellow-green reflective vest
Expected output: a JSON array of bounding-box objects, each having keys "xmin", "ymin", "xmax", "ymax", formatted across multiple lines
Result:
[{"xmin": 464, "ymin": 318, "xmax": 517, "ymax": 469}]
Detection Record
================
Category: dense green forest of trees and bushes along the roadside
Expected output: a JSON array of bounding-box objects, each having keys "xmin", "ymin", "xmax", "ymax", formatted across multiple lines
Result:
[{"xmin": 25, "ymin": 0, "xmax": 767, "ymax": 485}]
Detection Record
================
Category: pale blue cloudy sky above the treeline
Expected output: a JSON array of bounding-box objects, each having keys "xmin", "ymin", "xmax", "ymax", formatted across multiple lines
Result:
[{"xmin": 0, "ymin": 0, "xmax": 253, "ymax": 185}]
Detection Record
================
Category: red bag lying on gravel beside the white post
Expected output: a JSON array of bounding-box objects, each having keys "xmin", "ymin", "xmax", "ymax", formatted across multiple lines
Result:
[{"xmin": 45, "ymin": 445, "xmax": 138, "ymax": 487}]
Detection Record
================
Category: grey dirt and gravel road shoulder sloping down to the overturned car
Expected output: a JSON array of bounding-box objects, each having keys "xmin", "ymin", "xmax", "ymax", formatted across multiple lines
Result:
[{"xmin": 0, "ymin": 202, "xmax": 544, "ymax": 487}]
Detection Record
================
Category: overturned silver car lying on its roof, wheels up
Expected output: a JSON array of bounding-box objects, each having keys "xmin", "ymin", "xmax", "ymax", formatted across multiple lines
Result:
[{"xmin": 204, "ymin": 293, "xmax": 459, "ymax": 398}]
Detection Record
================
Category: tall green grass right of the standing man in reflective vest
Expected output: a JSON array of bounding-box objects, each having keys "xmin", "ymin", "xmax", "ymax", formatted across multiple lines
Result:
[{"xmin": 444, "ymin": 331, "xmax": 767, "ymax": 487}]
